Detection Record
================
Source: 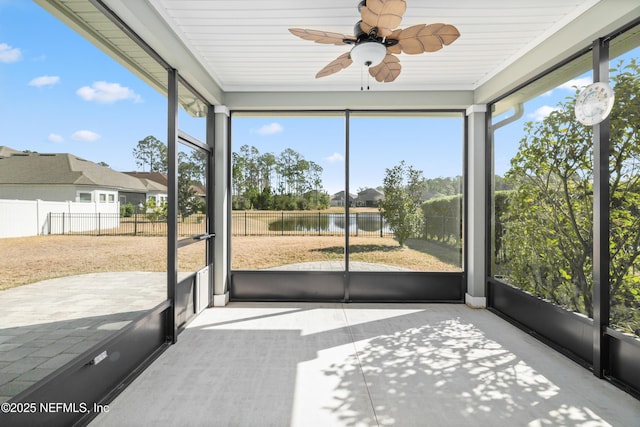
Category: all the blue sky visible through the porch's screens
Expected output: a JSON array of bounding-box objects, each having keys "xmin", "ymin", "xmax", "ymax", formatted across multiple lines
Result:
[{"xmin": 0, "ymin": 0, "xmax": 632, "ymax": 194}]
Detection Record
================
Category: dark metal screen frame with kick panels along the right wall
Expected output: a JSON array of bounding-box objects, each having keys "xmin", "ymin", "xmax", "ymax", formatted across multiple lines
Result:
[{"xmin": 485, "ymin": 19, "xmax": 640, "ymax": 398}]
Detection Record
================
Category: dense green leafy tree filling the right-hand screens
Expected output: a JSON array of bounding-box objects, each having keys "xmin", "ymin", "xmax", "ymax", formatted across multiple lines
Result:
[{"xmin": 497, "ymin": 60, "xmax": 640, "ymax": 333}]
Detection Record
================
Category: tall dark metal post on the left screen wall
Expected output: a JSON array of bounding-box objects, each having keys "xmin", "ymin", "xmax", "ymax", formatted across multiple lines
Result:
[{"xmin": 166, "ymin": 69, "xmax": 178, "ymax": 343}]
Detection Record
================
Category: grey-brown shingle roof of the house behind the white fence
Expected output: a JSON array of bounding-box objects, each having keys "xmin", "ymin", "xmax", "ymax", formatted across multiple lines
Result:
[{"xmin": 0, "ymin": 152, "xmax": 147, "ymax": 193}]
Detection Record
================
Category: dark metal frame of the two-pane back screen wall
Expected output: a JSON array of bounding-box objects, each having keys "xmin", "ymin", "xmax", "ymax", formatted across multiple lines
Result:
[{"xmin": 227, "ymin": 108, "xmax": 469, "ymax": 303}]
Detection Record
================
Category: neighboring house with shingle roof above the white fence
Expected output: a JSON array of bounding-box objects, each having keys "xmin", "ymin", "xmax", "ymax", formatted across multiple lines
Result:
[{"xmin": 0, "ymin": 147, "xmax": 167, "ymax": 205}]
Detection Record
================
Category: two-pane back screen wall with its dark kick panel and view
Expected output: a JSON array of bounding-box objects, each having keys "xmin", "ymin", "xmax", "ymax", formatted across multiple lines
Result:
[{"xmin": 231, "ymin": 111, "xmax": 465, "ymax": 301}]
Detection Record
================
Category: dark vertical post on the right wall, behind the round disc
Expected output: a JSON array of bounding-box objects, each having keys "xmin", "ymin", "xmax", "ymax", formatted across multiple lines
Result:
[{"xmin": 593, "ymin": 39, "xmax": 611, "ymax": 378}]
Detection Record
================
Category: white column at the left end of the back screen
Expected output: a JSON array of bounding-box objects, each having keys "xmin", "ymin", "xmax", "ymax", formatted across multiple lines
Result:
[{"xmin": 213, "ymin": 105, "xmax": 230, "ymax": 307}]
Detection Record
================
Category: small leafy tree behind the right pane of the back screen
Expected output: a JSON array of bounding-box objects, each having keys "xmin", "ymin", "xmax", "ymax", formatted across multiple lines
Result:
[{"xmin": 379, "ymin": 160, "xmax": 426, "ymax": 246}]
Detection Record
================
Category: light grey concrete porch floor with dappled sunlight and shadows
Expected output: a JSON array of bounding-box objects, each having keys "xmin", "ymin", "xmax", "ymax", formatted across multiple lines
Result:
[{"xmin": 91, "ymin": 303, "xmax": 640, "ymax": 427}]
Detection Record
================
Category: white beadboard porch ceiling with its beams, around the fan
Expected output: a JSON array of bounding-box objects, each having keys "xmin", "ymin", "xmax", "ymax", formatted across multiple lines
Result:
[{"xmin": 42, "ymin": 0, "xmax": 640, "ymax": 108}]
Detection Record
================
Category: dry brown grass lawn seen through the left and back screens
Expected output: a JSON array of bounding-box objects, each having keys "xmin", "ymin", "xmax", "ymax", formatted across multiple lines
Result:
[{"xmin": 0, "ymin": 236, "xmax": 460, "ymax": 290}]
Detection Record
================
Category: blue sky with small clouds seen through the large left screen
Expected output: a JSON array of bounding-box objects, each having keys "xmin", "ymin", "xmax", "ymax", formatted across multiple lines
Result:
[{"xmin": 0, "ymin": 0, "xmax": 166, "ymax": 171}]
